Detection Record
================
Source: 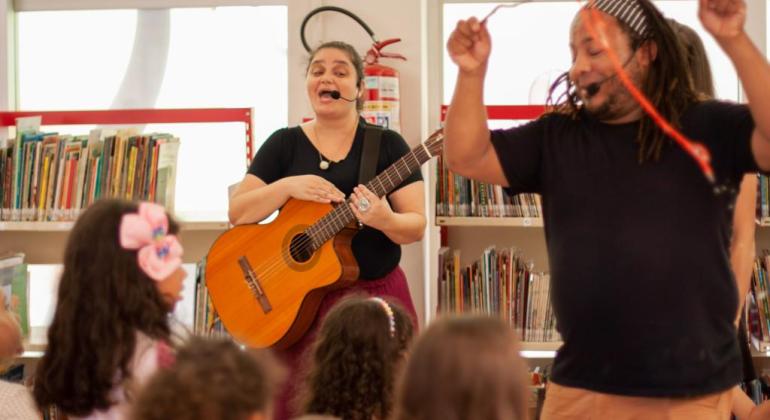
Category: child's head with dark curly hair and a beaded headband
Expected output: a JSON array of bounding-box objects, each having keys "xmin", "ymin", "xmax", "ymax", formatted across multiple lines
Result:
[{"xmin": 304, "ymin": 297, "xmax": 413, "ymax": 420}]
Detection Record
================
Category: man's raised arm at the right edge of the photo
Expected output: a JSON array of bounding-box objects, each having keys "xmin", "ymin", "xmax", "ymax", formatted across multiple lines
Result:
[{"xmin": 698, "ymin": 0, "xmax": 770, "ymax": 171}]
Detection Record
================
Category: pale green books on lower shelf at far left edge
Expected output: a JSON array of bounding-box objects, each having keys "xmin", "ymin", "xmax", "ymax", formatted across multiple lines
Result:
[{"xmin": 0, "ymin": 253, "xmax": 29, "ymax": 338}]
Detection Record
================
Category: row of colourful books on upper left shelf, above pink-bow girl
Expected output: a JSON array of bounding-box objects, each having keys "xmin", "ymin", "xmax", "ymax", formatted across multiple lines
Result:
[{"xmin": 0, "ymin": 117, "xmax": 180, "ymax": 221}]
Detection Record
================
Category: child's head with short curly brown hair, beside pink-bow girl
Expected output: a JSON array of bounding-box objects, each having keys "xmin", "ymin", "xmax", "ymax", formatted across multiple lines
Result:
[{"xmin": 132, "ymin": 338, "xmax": 282, "ymax": 420}]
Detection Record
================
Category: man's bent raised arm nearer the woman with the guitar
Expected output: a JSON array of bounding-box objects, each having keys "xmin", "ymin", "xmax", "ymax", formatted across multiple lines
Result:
[{"xmin": 444, "ymin": 18, "xmax": 507, "ymax": 186}]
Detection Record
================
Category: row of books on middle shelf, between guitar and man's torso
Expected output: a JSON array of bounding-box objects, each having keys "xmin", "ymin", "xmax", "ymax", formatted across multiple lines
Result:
[{"xmin": 438, "ymin": 247, "xmax": 561, "ymax": 342}]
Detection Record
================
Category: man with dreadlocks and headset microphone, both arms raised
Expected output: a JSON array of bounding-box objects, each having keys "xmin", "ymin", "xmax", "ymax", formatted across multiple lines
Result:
[{"xmin": 444, "ymin": 0, "xmax": 770, "ymax": 420}]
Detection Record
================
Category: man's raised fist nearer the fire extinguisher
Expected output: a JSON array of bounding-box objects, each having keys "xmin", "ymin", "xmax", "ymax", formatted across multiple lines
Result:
[{"xmin": 447, "ymin": 17, "xmax": 492, "ymax": 74}]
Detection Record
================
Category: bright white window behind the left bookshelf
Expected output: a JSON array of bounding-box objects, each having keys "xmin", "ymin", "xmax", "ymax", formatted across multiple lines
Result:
[{"xmin": 17, "ymin": 6, "xmax": 288, "ymax": 220}]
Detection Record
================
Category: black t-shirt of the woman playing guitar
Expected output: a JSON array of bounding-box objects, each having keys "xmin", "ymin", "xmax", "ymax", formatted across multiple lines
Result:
[{"xmin": 248, "ymin": 119, "xmax": 422, "ymax": 280}]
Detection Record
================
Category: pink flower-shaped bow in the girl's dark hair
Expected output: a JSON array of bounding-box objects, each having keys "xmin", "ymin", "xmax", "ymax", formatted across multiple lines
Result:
[{"xmin": 120, "ymin": 202, "xmax": 183, "ymax": 281}]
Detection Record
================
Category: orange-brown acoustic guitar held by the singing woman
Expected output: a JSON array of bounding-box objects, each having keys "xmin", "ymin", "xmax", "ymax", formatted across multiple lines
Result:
[{"xmin": 206, "ymin": 130, "xmax": 443, "ymax": 348}]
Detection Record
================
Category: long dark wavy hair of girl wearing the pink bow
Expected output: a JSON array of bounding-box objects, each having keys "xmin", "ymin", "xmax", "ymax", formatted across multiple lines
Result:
[{"xmin": 34, "ymin": 199, "xmax": 179, "ymax": 416}]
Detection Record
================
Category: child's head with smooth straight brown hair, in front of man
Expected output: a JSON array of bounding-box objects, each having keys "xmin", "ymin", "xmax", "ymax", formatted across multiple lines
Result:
[{"xmin": 394, "ymin": 316, "xmax": 528, "ymax": 420}]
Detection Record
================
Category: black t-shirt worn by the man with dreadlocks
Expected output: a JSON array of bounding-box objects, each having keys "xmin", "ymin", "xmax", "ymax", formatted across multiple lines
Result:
[{"xmin": 491, "ymin": 101, "xmax": 758, "ymax": 396}]
